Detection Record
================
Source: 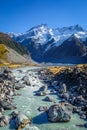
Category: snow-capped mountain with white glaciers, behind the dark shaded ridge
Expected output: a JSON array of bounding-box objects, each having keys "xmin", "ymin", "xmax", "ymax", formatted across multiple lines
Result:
[{"xmin": 8, "ymin": 24, "xmax": 87, "ymax": 63}]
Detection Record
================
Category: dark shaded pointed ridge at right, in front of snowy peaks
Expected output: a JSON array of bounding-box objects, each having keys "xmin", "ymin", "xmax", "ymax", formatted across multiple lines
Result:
[{"xmin": 43, "ymin": 36, "xmax": 87, "ymax": 63}]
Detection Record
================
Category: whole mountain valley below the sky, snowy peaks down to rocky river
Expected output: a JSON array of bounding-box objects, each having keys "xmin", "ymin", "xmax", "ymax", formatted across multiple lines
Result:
[{"xmin": 0, "ymin": 24, "xmax": 87, "ymax": 130}]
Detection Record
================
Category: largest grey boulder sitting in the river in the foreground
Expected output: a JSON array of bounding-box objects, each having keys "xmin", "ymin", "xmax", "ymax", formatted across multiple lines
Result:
[{"xmin": 47, "ymin": 104, "xmax": 71, "ymax": 122}]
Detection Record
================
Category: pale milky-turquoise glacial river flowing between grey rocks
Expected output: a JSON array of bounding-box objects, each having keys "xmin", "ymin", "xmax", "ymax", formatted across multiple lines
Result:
[{"xmin": 0, "ymin": 67, "xmax": 86, "ymax": 130}]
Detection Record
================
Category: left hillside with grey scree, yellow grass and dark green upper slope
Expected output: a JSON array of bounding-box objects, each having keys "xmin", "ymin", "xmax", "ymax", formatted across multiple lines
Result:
[{"xmin": 0, "ymin": 33, "xmax": 31, "ymax": 63}]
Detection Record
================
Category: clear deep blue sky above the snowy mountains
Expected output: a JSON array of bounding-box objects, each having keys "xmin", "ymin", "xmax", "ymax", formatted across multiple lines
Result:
[{"xmin": 0, "ymin": 0, "xmax": 87, "ymax": 33}]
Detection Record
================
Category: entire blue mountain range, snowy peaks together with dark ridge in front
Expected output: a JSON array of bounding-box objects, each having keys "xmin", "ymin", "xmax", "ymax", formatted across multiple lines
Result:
[{"xmin": 9, "ymin": 24, "xmax": 87, "ymax": 63}]
